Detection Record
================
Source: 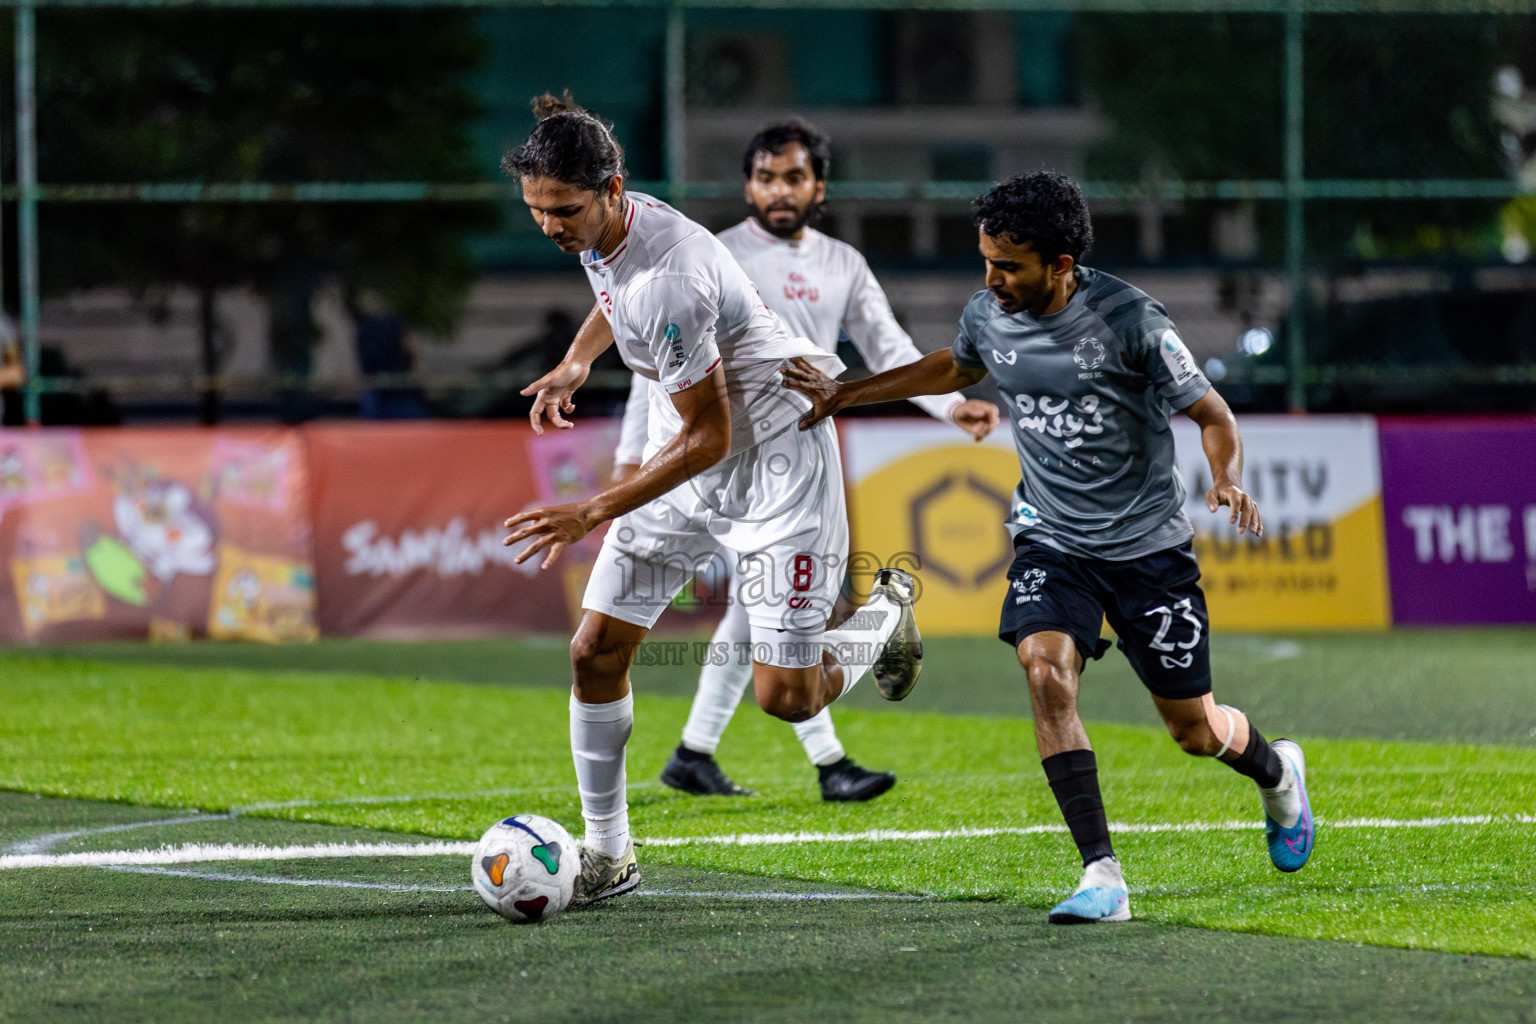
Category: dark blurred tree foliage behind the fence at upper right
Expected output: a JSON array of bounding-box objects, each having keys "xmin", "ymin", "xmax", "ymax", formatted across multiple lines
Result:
[{"xmin": 1077, "ymin": 14, "xmax": 1531, "ymax": 259}]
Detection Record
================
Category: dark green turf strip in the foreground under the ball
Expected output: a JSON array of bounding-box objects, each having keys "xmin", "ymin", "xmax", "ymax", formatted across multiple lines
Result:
[{"xmin": 9, "ymin": 794, "xmax": 1536, "ymax": 1024}]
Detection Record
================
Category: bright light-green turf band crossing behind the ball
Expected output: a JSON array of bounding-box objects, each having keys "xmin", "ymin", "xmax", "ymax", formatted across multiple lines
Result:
[{"xmin": 0, "ymin": 645, "xmax": 1536, "ymax": 956}]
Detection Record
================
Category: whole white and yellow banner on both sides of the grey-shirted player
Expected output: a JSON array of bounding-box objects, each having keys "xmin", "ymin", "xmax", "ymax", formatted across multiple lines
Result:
[{"xmin": 842, "ymin": 416, "xmax": 1389, "ymax": 636}]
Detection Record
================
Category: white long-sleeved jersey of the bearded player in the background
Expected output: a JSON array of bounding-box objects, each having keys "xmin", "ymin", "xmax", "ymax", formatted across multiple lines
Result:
[{"xmin": 717, "ymin": 216, "xmax": 965, "ymax": 422}]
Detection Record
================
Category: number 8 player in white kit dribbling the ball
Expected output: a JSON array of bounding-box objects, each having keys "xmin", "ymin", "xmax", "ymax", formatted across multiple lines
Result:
[{"xmin": 504, "ymin": 95, "xmax": 922, "ymax": 906}]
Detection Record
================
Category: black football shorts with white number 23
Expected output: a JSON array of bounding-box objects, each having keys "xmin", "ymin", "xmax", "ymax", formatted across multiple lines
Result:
[{"xmin": 997, "ymin": 540, "xmax": 1210, "ymax": 700}]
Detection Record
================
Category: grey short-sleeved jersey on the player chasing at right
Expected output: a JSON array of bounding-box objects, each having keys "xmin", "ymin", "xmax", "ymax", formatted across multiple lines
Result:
[{"xmin": 954, "ymin": 267, "xmax": 1210, "ymax": 562}]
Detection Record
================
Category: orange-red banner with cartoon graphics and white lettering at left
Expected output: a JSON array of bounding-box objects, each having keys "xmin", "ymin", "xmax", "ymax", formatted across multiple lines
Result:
[{"xmin": 0, "ymin": 419, "xmax": 737, "ymax": 643}]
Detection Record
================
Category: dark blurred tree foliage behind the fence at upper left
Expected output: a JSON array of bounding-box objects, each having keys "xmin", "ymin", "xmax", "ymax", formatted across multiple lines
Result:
[{"xmin": 13, "ymin": 8, "xmax": 498, "ymax": 411}]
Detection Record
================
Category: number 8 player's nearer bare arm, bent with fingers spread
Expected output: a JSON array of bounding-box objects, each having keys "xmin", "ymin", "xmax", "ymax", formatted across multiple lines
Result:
[{"xmin": 502, "ymin": 365, "xmax": 731, "ymax": 570}]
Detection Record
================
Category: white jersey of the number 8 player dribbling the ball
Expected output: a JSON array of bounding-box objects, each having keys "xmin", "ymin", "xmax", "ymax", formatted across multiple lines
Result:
[{"xmin": 582, "ymin": 192, "xmax": 846, "ymax": 457}]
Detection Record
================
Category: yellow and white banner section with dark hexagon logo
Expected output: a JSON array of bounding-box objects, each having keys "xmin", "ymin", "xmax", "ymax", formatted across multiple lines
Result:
[{"xmin": 839, "ymin": 419, "xmax": 1018, "ymax": 636}]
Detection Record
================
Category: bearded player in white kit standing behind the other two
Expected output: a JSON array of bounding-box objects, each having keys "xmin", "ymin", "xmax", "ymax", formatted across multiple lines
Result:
[{"xmin": 614, "ymin": 118, "xmax": 998, "ymax": 801}]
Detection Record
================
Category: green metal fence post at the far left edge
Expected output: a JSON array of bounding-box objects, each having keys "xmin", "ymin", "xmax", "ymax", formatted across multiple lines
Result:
[{"xmin": 15, "ymin": 0, "xmax": 43, "ymax": 424}]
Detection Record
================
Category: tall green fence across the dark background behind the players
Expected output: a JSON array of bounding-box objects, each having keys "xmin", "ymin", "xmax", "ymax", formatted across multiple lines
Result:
[{"xmin": 6, "ymin": 0, "xmax": 1536, "ymax": 419}]
